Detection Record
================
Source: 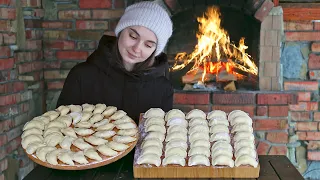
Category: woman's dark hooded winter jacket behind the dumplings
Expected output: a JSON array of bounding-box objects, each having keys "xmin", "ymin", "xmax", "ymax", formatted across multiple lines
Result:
[{"xmin": 57, "ymin": 35, "xmax": 173, "ymax": 122}]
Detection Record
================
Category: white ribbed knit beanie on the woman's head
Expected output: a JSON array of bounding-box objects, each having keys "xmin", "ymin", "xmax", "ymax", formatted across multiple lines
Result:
[{"xmin": 115, "ymin": 1, "xmax": 172, "ymax": 56}]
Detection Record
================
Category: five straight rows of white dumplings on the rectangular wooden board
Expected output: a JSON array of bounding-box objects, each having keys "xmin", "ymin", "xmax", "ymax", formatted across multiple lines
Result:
[{"xmin": 138, "ymin": 108, "xmax": 257, "ymax": 167}]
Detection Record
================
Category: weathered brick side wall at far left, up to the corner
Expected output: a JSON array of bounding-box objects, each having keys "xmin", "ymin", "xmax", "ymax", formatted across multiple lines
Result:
[{"xmin": 0, "ymin": 0, "xmax": 44, "ymax": 179}]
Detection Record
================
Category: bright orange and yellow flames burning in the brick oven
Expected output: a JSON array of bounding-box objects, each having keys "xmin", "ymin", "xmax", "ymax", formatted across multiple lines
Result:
[{"xmin": 171, "ymin": 7, "xmax": 258, "ymax": 82}]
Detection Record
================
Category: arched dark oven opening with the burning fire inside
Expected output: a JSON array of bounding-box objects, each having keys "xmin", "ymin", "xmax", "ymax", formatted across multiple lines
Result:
[{"xmin": 167, "ymin": 4, "xmax": 261, "ymax": 91}]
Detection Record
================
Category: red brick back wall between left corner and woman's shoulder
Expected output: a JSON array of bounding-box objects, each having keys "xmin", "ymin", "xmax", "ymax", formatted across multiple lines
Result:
[{"xmin": 41, "ymin": 0, "xmax": 125, "ymax": 108}]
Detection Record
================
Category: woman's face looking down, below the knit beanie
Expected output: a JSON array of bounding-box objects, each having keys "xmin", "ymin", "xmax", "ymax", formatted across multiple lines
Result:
[{"xmin": 118, "ymin": 26, "xmax": 157, "ymax": 66}]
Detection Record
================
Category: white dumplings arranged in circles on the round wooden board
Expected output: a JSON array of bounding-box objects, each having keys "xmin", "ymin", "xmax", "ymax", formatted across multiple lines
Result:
[{"xmin": 21, "ymin": 104, "xmax": 138, "ymax": 165}]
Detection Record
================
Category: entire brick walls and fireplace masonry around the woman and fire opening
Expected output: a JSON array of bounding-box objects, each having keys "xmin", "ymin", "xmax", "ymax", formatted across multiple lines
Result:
[{"xmin": 0, "ymin": 0, "xmax": 320, "ymax": 179}]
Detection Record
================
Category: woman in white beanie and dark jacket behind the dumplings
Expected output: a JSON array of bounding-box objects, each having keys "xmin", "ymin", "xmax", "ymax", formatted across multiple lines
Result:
[{"xmin": 57, "ymin": 2, "xmax": 173, "ymax": 122}]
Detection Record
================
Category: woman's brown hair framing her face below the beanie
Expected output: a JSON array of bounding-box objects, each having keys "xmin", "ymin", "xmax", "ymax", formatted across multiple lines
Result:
[{"xmin": 113, "ymin": 32, "xmax": 155, "ymax": 74}]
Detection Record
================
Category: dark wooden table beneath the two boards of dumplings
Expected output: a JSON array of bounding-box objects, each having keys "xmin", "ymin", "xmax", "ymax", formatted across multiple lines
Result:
[{"xmin": 24, "ymin": 153, "xmax": 304, "ymax": 180}]
